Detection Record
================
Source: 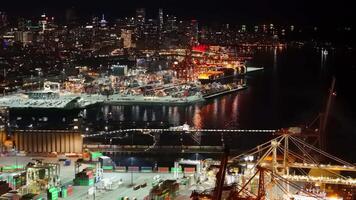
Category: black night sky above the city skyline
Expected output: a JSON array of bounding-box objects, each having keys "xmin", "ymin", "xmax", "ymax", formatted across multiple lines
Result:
[{"xmin": 0, "ymin": 0, "xmax": 356, "ymax": 25}]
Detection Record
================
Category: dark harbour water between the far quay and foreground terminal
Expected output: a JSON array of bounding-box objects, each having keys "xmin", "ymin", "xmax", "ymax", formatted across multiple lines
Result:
[{"xmin": 9, "ymin": 48, "xmax": 356, "ymax": 165}]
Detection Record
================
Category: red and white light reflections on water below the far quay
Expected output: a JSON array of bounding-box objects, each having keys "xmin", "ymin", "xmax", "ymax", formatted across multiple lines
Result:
[{"xmin": 94, "ymin": 92, "xmax": 243, "ymax": 128}]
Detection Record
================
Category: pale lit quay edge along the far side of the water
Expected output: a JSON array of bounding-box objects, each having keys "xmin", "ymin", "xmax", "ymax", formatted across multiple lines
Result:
[{"xmin": 0, "ymin": 67, "xmax": 263, "ymax": 110}]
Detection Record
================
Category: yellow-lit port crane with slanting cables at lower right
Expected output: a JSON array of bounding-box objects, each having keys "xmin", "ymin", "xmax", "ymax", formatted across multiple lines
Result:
[{"xmin": 232, "ymin": 130, "xmax": 356, "ymax": 187}]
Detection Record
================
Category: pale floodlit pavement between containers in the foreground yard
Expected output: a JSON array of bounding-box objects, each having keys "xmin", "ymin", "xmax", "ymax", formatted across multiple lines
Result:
[{"xmin": 0, "ymin": 156, "xmax": 200, "ymax": 200}]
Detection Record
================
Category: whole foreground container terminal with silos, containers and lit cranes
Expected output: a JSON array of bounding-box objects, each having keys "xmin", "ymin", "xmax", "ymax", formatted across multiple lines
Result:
[{"xmin": 0, "ymin": 76, "xmax": 356, "ymax": 200}]
